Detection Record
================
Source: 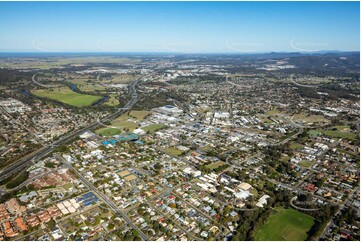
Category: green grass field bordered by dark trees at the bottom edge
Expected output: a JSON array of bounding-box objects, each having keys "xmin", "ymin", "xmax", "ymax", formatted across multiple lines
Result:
[{"xmin": 255, "ymin": 208, "xmax": 314, "ymax": 241}]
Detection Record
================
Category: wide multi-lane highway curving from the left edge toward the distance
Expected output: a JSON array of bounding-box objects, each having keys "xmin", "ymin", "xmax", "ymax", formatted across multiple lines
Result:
[{"xmin": 0, "ymin": 76, "xmax": 143, "ymax": 181}]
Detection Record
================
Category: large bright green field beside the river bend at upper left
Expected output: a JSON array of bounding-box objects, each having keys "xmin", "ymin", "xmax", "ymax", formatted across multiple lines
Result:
[{"xmin": 32, "ymin": 87, "xmax": 101, "ymax": 107}]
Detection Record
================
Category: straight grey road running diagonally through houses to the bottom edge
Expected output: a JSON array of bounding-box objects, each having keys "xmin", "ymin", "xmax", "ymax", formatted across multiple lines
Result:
[{"xmin": 62, "ymin": 159, "xmax": 149, "ymax": 240}]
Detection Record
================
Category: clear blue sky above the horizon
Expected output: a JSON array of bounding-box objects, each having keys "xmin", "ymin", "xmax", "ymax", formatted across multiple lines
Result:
[{"xmin": 0, "ymin": 2, "xmax": 360, "ymax": 53}]
